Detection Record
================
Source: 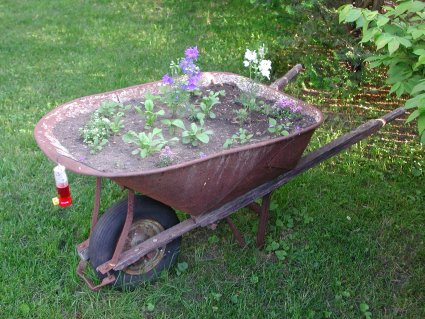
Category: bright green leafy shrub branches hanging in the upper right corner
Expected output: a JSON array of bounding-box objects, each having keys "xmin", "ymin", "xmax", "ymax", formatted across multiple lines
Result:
[{"xmin": 339, "ymin": 0, "xmax": 425, "ymax": 144}]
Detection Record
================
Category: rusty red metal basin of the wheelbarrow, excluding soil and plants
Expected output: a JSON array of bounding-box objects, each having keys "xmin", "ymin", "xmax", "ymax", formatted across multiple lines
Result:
[{"xmin": 34, "ymin": 72, "xmax": 323, "ymax": 216}]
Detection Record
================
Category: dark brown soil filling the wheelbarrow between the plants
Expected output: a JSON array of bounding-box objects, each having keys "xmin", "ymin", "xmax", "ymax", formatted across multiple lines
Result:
[{"xmin": 54, "ymin": 83, "xmax": 316, "ymax": 173}]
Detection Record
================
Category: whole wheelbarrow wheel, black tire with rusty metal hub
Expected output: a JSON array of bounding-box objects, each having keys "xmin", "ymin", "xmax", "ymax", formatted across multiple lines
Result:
[{"xmin": 89, "ymin": 195, "xmax": 181, "ymax": 288}]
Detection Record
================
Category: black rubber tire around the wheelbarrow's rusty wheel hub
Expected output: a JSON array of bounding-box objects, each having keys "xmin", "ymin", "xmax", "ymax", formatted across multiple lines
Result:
[{"xmin": 89, "ymin": 195, "xmax": 181, "ymax": 288}]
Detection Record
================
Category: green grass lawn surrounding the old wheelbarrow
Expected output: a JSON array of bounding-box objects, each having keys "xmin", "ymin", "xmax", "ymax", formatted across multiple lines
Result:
[{"xmin": 0, "ymin": 0, "xmax": 425, "ymax": 318}]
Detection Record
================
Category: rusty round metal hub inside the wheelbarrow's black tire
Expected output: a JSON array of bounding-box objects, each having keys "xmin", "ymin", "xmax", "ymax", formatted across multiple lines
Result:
[{"xmin": 123, "ymin": 219, "xmax": 165, "ymax": 275}]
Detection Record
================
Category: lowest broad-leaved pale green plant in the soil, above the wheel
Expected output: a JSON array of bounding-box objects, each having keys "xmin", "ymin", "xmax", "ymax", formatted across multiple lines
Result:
[{"xmin": 122, "ymin": 127, "xmax": 178, "ymax": 158}]
